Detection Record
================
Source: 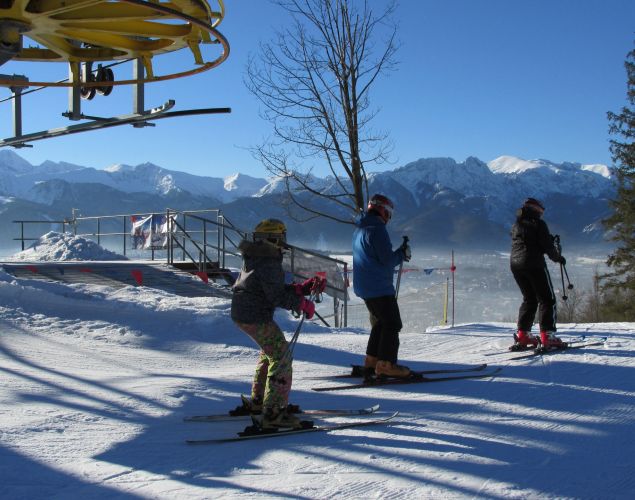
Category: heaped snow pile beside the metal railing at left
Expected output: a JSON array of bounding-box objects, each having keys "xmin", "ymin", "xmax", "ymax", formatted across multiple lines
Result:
[{"xmin": 10, "ymin": 231, "xmax": 128, "ymax": 262}]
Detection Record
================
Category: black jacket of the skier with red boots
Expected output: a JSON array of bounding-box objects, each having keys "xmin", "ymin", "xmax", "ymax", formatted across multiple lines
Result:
[{"xmin": 510, "ymin": 207, "xmax": 560, "ymax": 270}]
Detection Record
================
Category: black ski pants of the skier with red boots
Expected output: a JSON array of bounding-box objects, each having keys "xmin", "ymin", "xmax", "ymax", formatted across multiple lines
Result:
[{"xmin": 512, "ymin": 265, "xmax": 556, "ymax": 332}]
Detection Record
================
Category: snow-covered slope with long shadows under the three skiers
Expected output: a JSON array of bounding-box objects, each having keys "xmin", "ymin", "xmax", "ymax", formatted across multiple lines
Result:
[{"xmin": 0, "ymin": 236, "xmax": 635, "ymax": 499}]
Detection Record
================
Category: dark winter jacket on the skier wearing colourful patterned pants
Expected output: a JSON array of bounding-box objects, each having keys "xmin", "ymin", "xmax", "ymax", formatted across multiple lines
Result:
[{"xmin": 231, "ymin": 240, "xmax": 302, "ymax": 324}]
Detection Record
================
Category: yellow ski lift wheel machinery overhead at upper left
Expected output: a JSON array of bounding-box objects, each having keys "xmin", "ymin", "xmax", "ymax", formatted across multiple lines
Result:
[{"xmin": 0, "ymin": 0, "xmax": 231, "ymax": 147}]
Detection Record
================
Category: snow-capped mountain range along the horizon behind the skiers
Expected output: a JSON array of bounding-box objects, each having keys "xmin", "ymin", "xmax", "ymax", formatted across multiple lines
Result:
[{"xmin": 0, "ymin": 150, "xmax": 615, "ymax": 250}]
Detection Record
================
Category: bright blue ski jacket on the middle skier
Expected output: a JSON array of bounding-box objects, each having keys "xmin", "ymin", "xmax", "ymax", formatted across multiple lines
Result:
[{"xmin": 353, "ymin": 213, "xmax": 404, "ymax": 299}]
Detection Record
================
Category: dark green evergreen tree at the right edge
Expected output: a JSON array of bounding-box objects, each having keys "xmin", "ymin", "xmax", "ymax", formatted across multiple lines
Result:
[{"xmin": 603, "ymin": 42, "xmax": 635, "ymax": 321}]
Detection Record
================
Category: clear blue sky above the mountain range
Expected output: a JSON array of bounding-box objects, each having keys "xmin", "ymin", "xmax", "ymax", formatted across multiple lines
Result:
[{"xmin": 0, "ymin": 0, "xmax": 635, "ymax": 177}]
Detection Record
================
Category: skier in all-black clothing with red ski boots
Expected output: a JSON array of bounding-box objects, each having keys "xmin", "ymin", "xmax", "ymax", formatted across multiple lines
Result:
[{"xmin": 510, "ymin": 198, "xmax": 566, "ymax": 350}]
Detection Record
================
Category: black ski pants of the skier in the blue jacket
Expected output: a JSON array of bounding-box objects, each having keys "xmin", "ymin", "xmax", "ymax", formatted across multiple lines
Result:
[{"xmin": 364, "ymin": 295, "xmax": 403, "ymax": 363}]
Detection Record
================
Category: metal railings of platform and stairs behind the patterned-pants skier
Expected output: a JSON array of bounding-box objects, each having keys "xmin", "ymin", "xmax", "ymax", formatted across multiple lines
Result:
[{"xmin": 13, "ymin": 208, "xmax": 348, "ymax": 326}]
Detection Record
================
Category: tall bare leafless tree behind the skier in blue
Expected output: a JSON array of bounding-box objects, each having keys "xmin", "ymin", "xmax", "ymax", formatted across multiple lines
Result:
[{"xmin": 245, "ymin": 0, "xmax": 397, "ymax": 223}]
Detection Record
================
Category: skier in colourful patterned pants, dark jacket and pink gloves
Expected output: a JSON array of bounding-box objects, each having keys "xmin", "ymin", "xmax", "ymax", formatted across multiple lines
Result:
[{"xmin": 231, "ymin": 219, "xmax": 325, "ymax": 428}]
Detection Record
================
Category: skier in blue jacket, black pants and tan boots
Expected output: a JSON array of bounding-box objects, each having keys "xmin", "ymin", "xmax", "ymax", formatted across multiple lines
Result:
[{"xmin": 353, "ymin": 194, "xmax": 411, "ymax": 377}]
